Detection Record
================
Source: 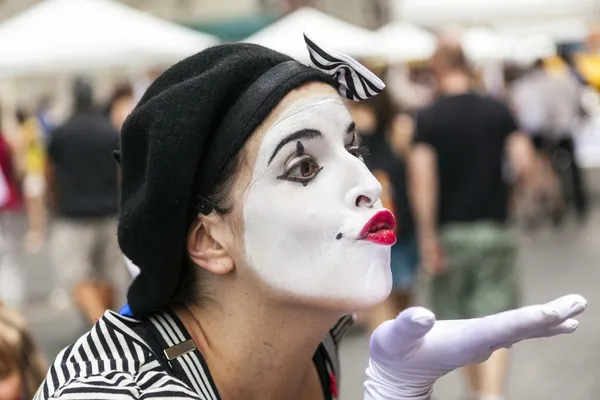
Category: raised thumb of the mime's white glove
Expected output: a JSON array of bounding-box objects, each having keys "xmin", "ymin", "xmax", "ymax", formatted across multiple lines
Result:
[{"xmin": 371, "ymin": 307, "xmax": 435, "ymax": 354}]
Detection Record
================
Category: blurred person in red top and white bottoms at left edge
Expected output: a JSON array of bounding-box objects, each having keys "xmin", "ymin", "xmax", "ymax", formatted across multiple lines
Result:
[{"xmin": 0, "ymin": 116, "xmax": 24, "ymax": 307}]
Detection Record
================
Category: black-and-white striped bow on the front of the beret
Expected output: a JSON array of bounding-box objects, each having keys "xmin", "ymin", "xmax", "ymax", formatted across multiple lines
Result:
[{"xmin": 304, "ymin": 33, "xmax": 385, "ymax": 101}]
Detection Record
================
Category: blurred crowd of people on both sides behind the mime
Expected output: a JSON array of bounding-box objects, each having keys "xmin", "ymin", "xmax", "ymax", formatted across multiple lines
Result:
[{"xmin": 0, "ymin": 28, "xmax": 593, "ymax": 400}]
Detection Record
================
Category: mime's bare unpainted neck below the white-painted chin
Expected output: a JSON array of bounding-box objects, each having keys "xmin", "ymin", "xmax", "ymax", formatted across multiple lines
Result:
[{"xmin": 177, "ymin": 295, "xmax": 336, "ymax": 400}]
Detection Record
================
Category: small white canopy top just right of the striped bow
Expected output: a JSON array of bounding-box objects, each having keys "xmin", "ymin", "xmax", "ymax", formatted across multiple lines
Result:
[{"xmin": 377, "ymin": 22, "xmax": 437, "ymax": 62}]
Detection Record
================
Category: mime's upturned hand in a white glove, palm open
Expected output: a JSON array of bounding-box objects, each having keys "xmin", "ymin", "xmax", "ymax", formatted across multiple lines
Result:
[{"xmin": 364, "ymin": 295, "xmax": 587, "ymax": 400}]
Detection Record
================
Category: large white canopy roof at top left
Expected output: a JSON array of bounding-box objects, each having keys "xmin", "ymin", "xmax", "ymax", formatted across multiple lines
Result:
[{"xmin": 0, "ymin": 0, "xmax": 217, "ymax": 77}]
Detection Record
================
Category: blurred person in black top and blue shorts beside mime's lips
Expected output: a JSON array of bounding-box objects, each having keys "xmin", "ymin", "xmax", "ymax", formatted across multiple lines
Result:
[{"xmin": 348, "ymin": 92, "xmax": 419, "ymax": 332}]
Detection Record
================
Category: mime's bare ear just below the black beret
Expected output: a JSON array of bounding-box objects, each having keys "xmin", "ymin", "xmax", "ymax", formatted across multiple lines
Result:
[{"xmin": 187, "ymin": 218, "xmax": 234, "ymax": 275}]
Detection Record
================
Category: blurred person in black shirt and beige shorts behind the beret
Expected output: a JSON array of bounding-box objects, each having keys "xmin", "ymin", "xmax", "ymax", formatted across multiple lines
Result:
[{"xmin": 47, "ymin": 79, "xmax": 128, "ymax": 323}]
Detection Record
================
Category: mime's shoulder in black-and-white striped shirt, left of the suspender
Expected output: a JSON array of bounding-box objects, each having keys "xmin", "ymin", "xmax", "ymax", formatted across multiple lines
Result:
[{"xmin": 35, "ymin": 311, "xmax": 201, "ymax": 400}]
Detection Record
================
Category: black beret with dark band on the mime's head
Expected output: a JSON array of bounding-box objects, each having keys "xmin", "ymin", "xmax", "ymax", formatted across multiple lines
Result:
[{"xmin": 118, "ymin": 44, "xmax": 334, "ymax": 317}]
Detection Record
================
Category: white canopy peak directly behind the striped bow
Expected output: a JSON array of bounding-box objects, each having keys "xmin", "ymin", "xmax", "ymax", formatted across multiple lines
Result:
[{"xmin": 243, "ymin": 7, "xmax": 381, "ymax": 62}]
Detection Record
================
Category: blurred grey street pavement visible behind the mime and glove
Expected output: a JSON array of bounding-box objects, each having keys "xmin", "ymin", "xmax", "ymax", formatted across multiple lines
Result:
[{"xmin": 8, "ymin": 208, "xmax": 600, "ymax": 400}]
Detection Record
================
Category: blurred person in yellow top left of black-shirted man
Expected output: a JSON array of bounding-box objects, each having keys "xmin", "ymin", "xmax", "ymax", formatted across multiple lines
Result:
[{"xmin": 16, "ymin": 109, "xmax": 47, "ymax": 253}]
